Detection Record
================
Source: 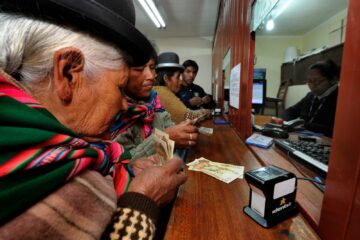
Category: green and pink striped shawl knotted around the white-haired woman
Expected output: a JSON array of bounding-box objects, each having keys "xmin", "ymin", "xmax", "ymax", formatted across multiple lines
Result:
[{"xmin": 0, "ymin": 70, "xmax": 131, "ymax": 224}]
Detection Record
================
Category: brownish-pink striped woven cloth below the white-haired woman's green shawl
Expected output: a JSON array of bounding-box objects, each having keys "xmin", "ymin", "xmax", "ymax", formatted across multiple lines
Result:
[{"xmin": 0, "ymin": 170, "xmax": 116, "ymax": 240}]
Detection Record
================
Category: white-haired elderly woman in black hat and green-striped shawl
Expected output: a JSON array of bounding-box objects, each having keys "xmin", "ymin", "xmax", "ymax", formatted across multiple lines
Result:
[{"xmin": 0, "ymin": 0, "xmax": 185, "ymax": 239}]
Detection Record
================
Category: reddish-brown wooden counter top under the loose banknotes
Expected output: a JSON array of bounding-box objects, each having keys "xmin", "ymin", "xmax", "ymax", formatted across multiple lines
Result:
[{"xmin": 165, "ymin": 121, "xmax": 318, "ymax": 240}]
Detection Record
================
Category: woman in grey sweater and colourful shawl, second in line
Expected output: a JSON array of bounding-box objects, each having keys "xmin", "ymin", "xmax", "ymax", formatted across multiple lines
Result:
[{"xmin": 111, "ymin": 52, "xmax": 198, "ymax": 159}]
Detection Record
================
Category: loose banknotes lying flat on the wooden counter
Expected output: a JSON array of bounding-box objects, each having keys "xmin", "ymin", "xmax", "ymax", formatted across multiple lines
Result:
[{"xmin": 186, "ymin": 158, "xmax": 244, "ymax": 183}]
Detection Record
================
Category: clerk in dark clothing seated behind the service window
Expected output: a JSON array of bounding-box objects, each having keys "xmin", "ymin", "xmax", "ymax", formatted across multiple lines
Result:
[{"xmin": 282, "ymin": 60, "xmax": 340, "ymax": 137}]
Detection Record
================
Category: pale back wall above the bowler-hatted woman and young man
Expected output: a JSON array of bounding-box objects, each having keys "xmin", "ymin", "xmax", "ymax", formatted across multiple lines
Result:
[{"xmin": 153, "ymin": 37, "xmax": 212, "ymax": 94}]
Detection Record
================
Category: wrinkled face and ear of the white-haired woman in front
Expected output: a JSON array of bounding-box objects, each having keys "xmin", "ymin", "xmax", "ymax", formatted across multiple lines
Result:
[{"xmin": 38, "ymin": 48, "xmax": 129, "ymax": 141}]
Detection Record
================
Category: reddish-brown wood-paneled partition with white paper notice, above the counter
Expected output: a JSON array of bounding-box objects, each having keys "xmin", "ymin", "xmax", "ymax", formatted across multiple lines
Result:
[{"xmin": 213, "ymin": 0, "xmax": 255, "ymax": 139}]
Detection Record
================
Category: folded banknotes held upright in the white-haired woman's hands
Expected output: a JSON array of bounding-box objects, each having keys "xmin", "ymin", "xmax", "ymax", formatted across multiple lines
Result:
[{"xmin": 153, "ymin": 128, "xmax": 175, "ymax": 165}]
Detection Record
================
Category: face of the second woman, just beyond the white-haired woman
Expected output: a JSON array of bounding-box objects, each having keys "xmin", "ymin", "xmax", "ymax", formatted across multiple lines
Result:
[{"xmin": 125, "ymin": 59, "xmax": 156, "ymax": 99}]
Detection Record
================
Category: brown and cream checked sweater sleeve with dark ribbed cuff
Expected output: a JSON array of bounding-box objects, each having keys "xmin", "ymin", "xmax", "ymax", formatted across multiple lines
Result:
[{"xmin": 103, "ymin": 192, "xmax": 160, "ymax": 240}]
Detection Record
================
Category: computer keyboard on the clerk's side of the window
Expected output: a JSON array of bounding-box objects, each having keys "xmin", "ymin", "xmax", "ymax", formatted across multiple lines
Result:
[{"xmin": 274, "ymin": 139, "xmax": 331, "ymax": 175}]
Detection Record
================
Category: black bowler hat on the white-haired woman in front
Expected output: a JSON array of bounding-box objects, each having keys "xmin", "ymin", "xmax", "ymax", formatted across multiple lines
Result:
[{"xmin": 0, "ymin": 0, "xmax": 154, "ymax": 65}]
